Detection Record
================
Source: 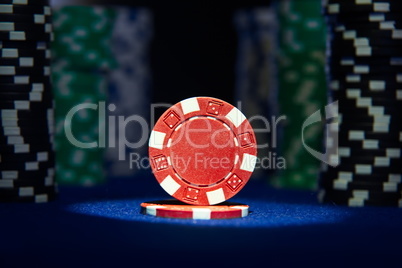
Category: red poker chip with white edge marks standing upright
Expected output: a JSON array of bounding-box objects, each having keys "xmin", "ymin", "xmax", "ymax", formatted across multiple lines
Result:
[{"xmin": 149, "ymin": 97, "xmax": 257, "ymax": 205}]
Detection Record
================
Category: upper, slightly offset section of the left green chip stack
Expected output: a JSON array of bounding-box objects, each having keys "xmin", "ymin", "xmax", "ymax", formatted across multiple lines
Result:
[{"xmin": 52, "ymin": 6, "xmax": 117, "ymax": 70}]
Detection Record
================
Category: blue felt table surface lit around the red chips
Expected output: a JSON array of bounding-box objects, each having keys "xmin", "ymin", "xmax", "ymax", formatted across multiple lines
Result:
[{"xmin": 0, "ymin": 174, "xmax": 402, "ymax": 267}]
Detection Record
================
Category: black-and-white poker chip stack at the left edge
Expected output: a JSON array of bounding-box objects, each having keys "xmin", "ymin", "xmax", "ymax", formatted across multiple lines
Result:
[{"xmin": 0, "ymin": 0, "xmax": 57, "ymax": 203}]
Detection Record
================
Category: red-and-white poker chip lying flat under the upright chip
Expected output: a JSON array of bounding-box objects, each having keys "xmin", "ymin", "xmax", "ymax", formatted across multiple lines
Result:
[{"xmin": 141, "ymin": 200, "xmax": 249, "ymax": 220}]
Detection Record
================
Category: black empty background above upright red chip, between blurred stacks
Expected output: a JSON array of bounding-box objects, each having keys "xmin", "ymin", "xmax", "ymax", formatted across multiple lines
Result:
[{"xmin": 92, "ymin": 0, "xmax": 270, "ymax": 104}]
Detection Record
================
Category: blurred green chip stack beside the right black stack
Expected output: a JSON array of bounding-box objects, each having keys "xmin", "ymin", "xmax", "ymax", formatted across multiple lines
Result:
[{"xmin": 272, "ymin": 0, "xmax": 326, "ymax": 189}]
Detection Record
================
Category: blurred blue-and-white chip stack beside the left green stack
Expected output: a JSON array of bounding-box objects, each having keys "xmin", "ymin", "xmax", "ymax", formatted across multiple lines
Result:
[{"xmin": 107, "ymin": 7, "xmax": 153, "ymax": 177}]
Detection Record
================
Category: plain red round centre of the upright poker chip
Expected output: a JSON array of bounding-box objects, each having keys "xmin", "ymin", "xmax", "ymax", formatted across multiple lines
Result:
[{"xmin": 170, "ymin": 116, "xmax": 238, "ymax": 186}]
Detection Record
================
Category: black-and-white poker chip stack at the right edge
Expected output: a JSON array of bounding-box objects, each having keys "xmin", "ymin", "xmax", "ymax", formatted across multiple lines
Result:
[{"xmin": 319, "ymin": 0, "xmax": 402, "ymax": 206}]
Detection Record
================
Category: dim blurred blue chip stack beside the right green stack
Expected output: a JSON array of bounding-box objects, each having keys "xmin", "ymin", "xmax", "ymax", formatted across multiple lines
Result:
[{"xmin": 234, "ymin": 7, "xmax": 278, "ymax": 179}]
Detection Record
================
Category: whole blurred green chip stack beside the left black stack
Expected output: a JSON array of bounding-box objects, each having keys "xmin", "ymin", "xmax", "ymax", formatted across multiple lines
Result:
[{"xmin": 52, "ymin": 6, "xmax": 116, "ymax": 186}]
